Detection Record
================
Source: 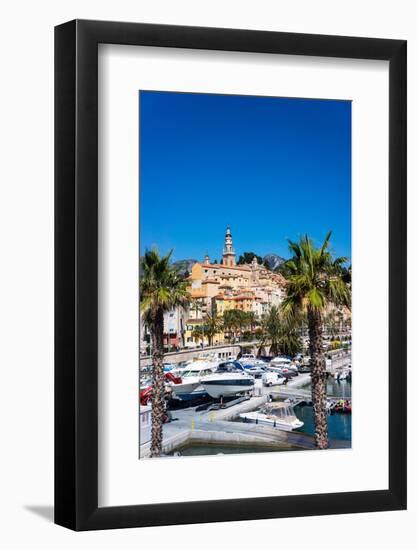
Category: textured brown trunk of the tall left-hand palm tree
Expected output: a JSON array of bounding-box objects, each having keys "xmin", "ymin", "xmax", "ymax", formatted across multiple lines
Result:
[{"xmin": 151, "ymin": 310, "xmax": 165, "ymax": 457}]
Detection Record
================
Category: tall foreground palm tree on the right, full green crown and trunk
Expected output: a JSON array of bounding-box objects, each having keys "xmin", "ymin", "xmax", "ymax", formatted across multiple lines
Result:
[{"xmin": 282, "ymin": 235, "xmax": 351, "ymax": 449}]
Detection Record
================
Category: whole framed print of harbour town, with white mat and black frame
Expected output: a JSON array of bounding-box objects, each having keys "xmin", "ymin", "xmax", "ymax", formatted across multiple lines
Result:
[{"xmin": 55, "ymin": 21, "xmax": 406, "ymax": 530}]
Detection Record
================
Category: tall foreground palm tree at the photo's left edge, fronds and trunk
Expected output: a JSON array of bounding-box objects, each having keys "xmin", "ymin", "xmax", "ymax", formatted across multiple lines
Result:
[{"xmin": 140, "ymin": 250, "xmax": 189, "ymax": 457}]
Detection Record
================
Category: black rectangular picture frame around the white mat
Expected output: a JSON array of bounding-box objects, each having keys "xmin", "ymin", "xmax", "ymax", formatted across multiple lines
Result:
[{"xmin": 55, "ymin": 20, "xmax": 407, "ymax": 530}]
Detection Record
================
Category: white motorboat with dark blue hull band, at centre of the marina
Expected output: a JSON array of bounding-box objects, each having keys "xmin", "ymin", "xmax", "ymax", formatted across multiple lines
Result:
[{"xmin": 201, "ymin": 361, "xmax": 255, "ymax": 399}]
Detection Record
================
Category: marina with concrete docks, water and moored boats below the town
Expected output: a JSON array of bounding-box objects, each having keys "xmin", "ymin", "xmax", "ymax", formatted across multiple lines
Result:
[{"xmin": 140, "ymin": 354, "xmax": 351, "ymax": 457}]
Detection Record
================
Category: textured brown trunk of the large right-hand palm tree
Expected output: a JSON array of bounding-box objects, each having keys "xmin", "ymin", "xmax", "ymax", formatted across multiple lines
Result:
[{"xmin": 308, "ymin": 308, "xmax": 329, "ymax": 449}]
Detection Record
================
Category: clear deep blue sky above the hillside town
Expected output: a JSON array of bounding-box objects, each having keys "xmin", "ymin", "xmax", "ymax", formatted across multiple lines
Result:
[{"xmin": 139, "ymin": 91, "xmax": 351, "ymax": 261}]
